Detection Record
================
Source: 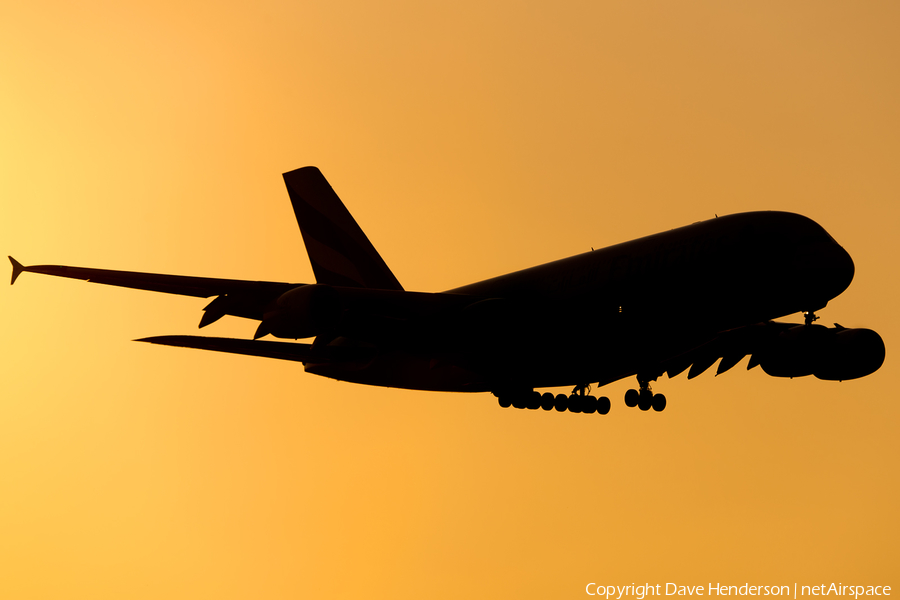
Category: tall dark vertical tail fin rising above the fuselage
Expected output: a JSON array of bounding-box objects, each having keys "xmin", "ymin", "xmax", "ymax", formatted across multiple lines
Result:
[{"xmin": 284, "ymin": 167, "xmax": 403, "ymax": 290}]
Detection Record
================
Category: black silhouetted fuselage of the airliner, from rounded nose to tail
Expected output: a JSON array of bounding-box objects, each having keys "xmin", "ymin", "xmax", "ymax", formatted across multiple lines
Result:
[{"xmin": 307, "ymin": 212, "xmax": 854, "ymax": 391}]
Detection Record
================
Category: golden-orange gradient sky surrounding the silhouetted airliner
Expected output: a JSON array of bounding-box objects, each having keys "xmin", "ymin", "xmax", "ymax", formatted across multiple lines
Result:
[{"xmin": 0, "ymin": 0, "xmax": 900, "ymax": 598}]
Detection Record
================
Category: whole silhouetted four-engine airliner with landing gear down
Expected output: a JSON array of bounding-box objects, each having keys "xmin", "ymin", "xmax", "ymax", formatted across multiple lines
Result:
[{"xmin": 10, "ymin": 167, "xmax": 885, "ymax": 414}]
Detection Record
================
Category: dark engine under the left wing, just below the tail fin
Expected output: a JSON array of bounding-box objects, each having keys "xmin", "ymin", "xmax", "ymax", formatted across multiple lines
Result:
[{"xmin": 256, "ymin": 283, "xmax": 343, "ymax": 339}]
